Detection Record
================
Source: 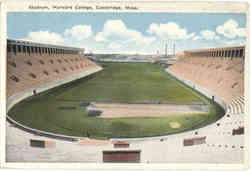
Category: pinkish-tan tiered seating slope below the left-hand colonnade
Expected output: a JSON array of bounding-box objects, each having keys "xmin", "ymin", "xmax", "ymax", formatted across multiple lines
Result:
[{"xmin": 7, "ymin": 46, "xmax": 97, "ymax": 97}]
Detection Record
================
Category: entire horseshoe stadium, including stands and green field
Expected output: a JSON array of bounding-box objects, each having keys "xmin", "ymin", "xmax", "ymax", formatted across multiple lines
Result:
[{"xmin": 6, "ymin": 40, "xmax": 245, "ymax": 164}]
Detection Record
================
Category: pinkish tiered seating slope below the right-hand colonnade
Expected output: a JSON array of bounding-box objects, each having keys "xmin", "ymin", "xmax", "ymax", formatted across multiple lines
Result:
[{"xmin": 169, "ymin": 56, "xmax": 244, "ymax": 103}]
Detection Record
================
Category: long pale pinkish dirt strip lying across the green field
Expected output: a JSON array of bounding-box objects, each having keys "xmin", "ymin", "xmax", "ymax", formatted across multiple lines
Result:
[{"xmin": 88, "ymin": 103, "xmax": 208, "ymax": 118}]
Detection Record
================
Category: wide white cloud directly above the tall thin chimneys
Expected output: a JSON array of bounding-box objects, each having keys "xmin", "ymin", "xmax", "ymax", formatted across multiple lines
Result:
[{"xmin": 147, "ymin": 22, "xmax": 195, "ymax": 40}]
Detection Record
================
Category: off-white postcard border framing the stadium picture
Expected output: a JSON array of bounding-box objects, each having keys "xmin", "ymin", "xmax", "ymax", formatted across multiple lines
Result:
[{"xmin": 0, "ymin": 0, "xmax": 250, "ymax": 170}]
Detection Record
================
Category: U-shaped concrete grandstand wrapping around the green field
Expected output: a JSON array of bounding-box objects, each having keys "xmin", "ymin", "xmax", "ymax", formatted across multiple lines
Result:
[{"xmin": 6, "ymin": 40, "xmax": 245, "ymax": 163}]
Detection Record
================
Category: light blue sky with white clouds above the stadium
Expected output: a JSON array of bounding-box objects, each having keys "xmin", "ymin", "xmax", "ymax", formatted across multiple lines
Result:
[{"xmin": 7, "ymin": 12, "xmax": 246, "ymax": 54}]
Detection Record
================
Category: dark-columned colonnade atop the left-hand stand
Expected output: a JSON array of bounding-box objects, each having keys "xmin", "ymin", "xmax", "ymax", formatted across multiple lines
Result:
[{"xmin": 7, "ymin": 40, "xmax": 84, "ymax": 55}]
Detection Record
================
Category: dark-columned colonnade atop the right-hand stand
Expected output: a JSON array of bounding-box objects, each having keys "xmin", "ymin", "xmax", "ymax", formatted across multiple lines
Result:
[{"xmin": 184, "ymin": 46, "xmax": 245, "ymax": 58}]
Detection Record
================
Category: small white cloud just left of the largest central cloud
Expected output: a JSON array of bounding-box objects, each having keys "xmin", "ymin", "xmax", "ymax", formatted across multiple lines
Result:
[{"xmin": 64, "ymin": 25, "xmax": 92, "ymax": 41}]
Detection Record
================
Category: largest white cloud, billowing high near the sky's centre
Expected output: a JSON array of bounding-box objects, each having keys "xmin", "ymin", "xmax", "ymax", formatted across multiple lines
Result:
[{"xmin": 95, "ymin": 20, "xmax": 155, "ymax": 45}]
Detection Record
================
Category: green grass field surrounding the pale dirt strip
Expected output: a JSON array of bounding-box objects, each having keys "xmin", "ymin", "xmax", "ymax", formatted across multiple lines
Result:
[{"xmin": 8, "ymin": 63, "xmax": 224, "ymax": 138}]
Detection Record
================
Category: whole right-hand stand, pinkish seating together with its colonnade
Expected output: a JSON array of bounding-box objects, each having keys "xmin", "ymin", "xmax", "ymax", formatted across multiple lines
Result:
[{"xmin": 169, "ymin": 47, "xmax": 244, "ymax": 103}]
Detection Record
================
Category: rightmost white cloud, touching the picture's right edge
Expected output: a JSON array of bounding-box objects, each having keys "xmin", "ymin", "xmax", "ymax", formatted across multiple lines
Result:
[{"xmin": 216, "ymin": 19, "xmax": 246, "ymax": 39}]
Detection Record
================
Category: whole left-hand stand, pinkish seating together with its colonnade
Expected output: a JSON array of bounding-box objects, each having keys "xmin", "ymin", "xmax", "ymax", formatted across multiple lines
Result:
[{"xmin": 7, "ymin": 40, "xmax": 98, "ymax": 97}]
